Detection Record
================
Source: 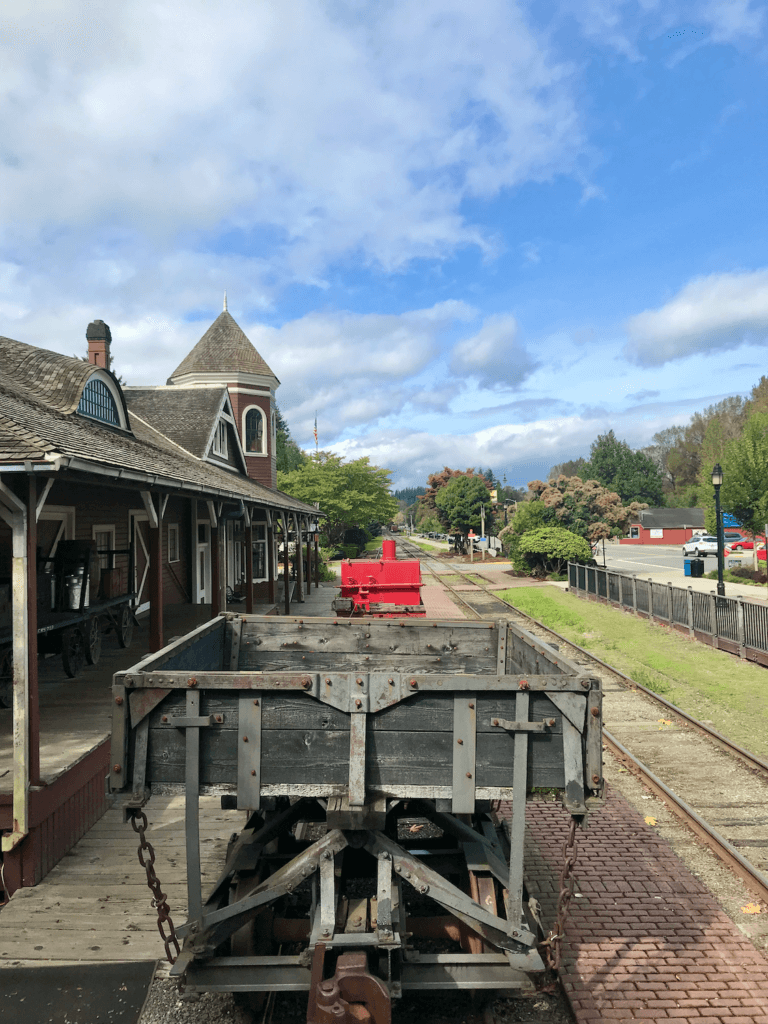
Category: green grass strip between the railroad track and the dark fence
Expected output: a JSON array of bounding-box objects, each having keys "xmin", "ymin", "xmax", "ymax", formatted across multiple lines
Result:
[{"xmin": 502, "ymin": 587, "xmax": 768, "ymax": 755}]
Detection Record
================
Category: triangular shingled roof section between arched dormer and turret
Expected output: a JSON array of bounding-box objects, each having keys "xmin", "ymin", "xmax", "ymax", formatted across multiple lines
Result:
[{"xmin": 123, "ymin": 385, "xmax": 226, "ymax": 459}]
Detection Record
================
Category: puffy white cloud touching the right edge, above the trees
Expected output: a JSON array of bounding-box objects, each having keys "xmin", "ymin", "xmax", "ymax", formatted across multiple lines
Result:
[{"xmin": 625, "ymin": 269, "xmax": 768, "ymax": 367}]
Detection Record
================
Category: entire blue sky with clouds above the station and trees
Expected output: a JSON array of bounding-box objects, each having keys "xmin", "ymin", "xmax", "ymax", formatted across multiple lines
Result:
[{"xmin": 0, "ymin": 0, "xmax": 768, "ymax": 485}]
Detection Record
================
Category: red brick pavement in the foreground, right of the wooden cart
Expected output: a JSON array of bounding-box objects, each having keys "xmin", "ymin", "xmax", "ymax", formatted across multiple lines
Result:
[{"xmin": 502, "ymin": 790, "xmax": 768, "ymax": 1024}]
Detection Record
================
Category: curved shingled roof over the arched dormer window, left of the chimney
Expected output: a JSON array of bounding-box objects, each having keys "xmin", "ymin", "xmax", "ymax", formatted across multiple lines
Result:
[{"xmin": 0, "ymin": 338, "xmax": 98, "ymax": 414}]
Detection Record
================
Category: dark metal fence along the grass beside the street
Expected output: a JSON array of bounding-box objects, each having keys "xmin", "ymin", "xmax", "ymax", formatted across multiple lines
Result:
[{"xmin": 568, "ymin": 562, "xmax": 768, "ymax": 665}]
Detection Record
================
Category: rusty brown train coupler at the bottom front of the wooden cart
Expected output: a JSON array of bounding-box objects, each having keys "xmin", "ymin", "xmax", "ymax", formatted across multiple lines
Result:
[{"xmin": 306, "ymin": 942, "xmax": 392, "ymax": 1024}]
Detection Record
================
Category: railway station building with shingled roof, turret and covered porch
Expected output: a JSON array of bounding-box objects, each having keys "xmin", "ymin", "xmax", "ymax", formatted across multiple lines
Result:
[{"xmin": 0, "ymin": 304, "xmax": 318, "ymax": 893}]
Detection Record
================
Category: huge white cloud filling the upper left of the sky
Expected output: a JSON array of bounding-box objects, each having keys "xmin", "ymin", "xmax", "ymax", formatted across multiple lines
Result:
[{"xmin": 0, "ymin": 0, "xmax": 583, "ymax": 281}]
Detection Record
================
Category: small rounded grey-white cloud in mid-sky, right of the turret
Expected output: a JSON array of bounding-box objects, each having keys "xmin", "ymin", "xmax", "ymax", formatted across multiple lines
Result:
[{"xmin": 451, "ymin": 313, "xmax": 537, "ymax": 387}]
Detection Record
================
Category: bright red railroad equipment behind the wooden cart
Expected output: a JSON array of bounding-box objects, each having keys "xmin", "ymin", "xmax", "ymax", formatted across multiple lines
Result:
[{"xmin": 333, "ymin": 541, "xmax": 426, "ymax": 618}]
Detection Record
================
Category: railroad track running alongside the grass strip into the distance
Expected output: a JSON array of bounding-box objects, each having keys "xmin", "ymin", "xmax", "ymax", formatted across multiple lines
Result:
[{"xmin": 398, "ymin": 541, "xmax": 768, "ymax": 903}]
